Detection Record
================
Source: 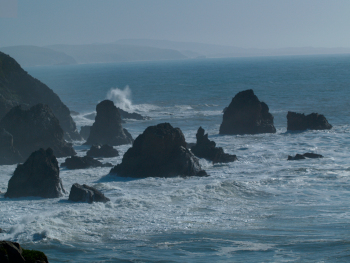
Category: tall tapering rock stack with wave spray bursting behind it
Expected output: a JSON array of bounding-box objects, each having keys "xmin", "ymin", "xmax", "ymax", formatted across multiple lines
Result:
[{"xmin": 85, "ymin": 100, "xmax": 133, "ymax": 146}]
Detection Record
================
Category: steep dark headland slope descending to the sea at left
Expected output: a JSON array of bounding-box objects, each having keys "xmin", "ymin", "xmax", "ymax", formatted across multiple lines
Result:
[{"xmin": 0, "ymin": 52, "xmax": 81, "ymax": 140}]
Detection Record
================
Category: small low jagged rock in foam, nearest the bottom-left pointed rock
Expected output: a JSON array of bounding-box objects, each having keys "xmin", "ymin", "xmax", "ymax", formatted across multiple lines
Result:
[{"xmin": 69, "ymin": 183, "xmax": 110, "ymax": 204}]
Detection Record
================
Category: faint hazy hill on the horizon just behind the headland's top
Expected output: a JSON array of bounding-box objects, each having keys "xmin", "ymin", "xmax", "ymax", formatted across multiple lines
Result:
[{"xmin": 0, "ymin": 46, "xmax": 77, "ymax": 67}]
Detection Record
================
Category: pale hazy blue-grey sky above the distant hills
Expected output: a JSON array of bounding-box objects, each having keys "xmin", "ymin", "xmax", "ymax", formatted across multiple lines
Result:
[{"xmin": 0, "ymin": 0, "xmax": 350, "ymax": 48}]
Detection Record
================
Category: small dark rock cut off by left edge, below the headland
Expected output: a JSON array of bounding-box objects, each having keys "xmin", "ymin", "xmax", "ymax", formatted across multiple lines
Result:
[{"xmin": 0, "ymin": 128, "xmax": 23, "ymax": 165}]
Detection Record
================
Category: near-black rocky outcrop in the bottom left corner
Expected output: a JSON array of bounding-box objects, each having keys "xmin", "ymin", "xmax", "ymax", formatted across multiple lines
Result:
[{"xmin": 0, "ymin": 241, "xmax": 49, "ymax": 263}]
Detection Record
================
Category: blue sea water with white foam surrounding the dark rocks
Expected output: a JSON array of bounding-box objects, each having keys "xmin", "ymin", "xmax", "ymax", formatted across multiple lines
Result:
[{"xmin": 0, "ymin": 55, "xmax": 350, "ymax": 262}]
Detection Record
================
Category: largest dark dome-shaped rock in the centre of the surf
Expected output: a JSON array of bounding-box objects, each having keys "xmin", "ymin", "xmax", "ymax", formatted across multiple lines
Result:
[{"xmin": 110, "ymin": 123, "xmax": 207, "ymax": 178}]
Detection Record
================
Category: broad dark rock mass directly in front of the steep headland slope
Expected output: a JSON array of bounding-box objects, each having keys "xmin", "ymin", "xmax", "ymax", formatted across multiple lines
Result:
[{"xmin": 0, "ymin": 104, "xmax": 75, "ymax": 158}]
